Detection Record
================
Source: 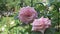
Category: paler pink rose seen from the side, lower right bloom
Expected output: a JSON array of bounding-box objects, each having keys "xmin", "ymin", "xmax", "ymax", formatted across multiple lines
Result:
[{"xmin": 32, "ymin": 17, "xmax": 51, "ymax": 33}]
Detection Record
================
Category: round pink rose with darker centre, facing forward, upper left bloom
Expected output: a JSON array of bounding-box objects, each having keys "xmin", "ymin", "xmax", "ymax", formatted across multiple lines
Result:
[{"xmin": 19, "ymin": 6, "xmax": 37, "ymax": 24}]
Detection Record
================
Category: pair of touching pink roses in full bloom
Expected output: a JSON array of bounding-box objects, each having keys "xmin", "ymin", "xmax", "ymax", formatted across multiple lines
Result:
[{"xmin": 19, "ymin": 6, "xmax": 51, "ymax": 32}]
